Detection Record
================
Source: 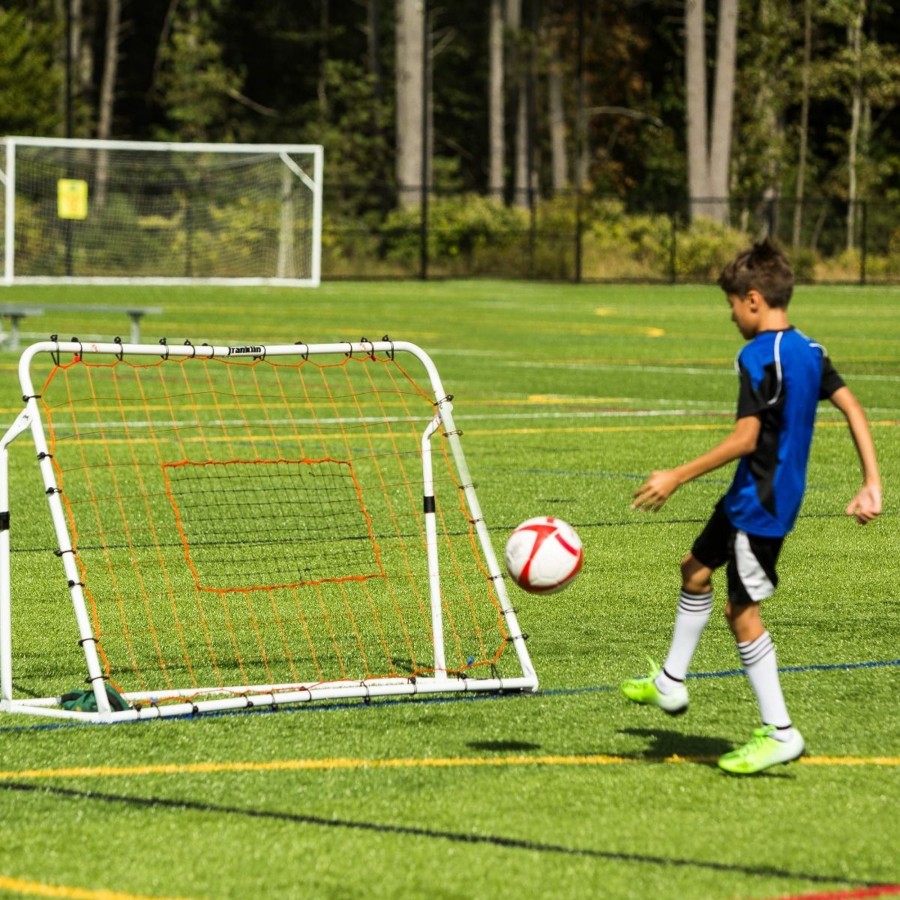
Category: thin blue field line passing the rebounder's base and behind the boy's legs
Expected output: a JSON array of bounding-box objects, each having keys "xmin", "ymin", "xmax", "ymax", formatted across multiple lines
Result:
[{"xmin": 0, "ymin": 659, "xmax": 900, "ymax": 735}]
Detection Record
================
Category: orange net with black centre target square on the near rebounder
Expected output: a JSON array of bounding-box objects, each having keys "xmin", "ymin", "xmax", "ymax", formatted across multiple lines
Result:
[{"xmin": 40, "ymin": 354, "xmax": 508, "ymax": 695}]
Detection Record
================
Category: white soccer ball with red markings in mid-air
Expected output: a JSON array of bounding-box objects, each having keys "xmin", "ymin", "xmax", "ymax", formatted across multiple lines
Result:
[{"xmin": 505, "ymin": 516, "xmax": 584, "ymax": 594}]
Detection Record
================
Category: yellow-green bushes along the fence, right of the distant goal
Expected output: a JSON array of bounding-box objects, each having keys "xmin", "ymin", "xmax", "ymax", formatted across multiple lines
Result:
[{"xmin": 316, "ymin": 194, "xmax": 900, "ymax": 283}]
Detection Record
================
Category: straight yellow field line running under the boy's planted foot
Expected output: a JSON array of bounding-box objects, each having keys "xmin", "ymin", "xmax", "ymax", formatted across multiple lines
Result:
[{"xmin": 0, "ymin": 754, "xmax": 900, "ymax": 781}]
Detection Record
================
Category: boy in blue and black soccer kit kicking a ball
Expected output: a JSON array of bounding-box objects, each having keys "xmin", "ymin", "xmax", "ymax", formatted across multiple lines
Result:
[{"xmin": 622, "ymin": 240, "xmax": 881, "ymax": 775}]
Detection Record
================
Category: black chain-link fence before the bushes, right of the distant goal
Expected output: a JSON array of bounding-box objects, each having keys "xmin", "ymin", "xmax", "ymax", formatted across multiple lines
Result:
[{"xmin": 322, "ymin": 185, "xmax": 900, "ymax": 285}]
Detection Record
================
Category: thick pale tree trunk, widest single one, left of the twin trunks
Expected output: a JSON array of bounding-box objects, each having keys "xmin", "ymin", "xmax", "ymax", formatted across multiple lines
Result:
[{"xmin": 396, "ymin": 0, "xmax": 425, "ymax": 207}]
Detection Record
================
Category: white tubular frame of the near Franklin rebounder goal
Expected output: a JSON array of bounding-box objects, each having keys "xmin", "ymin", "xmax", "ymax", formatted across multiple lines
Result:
[{"xmin": 0, "ymin": 340, "xmax": 538, "ymax": 723}]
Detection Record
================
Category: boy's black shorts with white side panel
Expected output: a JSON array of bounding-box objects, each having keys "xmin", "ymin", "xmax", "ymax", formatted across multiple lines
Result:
[{"xmin": 691, "ymin": 500, "xmax": 784, "ymax": 603}]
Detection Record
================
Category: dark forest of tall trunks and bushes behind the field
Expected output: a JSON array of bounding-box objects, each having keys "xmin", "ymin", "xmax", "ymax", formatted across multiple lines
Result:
[{"xmin": 0, "ymin": 0, "xmax": 900, "ymax": 282}]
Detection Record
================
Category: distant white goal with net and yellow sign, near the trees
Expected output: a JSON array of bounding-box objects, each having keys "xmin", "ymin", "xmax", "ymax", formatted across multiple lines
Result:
[{"xmin": 0, "ymin": 137, "xmax": 323, "ymax": 287}]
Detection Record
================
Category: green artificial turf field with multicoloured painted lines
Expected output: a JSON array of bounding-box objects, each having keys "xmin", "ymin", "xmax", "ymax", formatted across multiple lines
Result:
[{"xmin": 0, "ymin": 282, "xmax": 900, "ymax": 900}]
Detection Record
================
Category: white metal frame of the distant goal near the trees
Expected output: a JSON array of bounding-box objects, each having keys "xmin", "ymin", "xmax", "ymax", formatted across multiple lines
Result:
[{"xmin": 0, "ymin": 136, "xmax": 324, "ymax": 287}]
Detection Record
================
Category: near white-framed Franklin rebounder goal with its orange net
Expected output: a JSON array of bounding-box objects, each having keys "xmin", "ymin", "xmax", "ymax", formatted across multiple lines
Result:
[{"xmin": 0, "ymin": 337, "xmax": 537, "ymax": 722}]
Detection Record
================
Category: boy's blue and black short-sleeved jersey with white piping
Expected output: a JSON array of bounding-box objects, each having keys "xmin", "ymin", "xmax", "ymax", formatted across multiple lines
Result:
[{"xmin": 723, "ymin": 328, "xmax": 844, "ymax": 537}]
